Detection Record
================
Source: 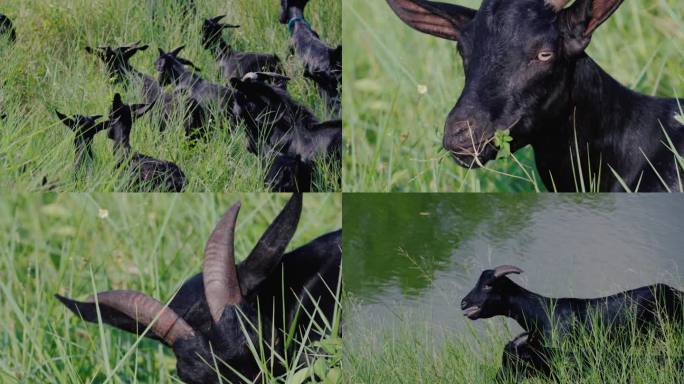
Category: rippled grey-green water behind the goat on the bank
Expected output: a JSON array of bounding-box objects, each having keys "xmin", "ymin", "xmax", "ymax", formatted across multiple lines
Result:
[{"xmin": 343, "ymin": 194, "xmax": 684, "ymax": 340}]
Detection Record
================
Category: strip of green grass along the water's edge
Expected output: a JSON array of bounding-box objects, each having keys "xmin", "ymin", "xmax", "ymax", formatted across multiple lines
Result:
[{"xmin": 343, "ymin": 306, "xmax": 684, "ymax": 384}]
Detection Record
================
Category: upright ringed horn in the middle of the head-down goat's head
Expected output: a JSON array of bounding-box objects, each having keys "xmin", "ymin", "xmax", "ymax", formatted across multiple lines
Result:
[{"xmin": 202, "ymin": 203, "xmax": 242, "ymax": 322}]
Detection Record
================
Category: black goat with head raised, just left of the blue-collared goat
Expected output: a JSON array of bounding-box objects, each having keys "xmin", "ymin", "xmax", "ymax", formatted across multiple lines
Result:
[{"xmin": 202, "ymin": 15, "xmax": 284, "ymax": 79}]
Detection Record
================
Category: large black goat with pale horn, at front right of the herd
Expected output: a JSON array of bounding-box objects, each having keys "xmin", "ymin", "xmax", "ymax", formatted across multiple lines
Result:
[{"xmin": 231, "ymin": 74, "xmax": 342, "ymax": 192}]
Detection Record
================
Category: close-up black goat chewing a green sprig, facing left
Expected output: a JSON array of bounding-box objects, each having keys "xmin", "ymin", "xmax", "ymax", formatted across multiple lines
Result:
[{"xmin": 387, "ymin": 0, "xmax": 684, "ymax": 191}]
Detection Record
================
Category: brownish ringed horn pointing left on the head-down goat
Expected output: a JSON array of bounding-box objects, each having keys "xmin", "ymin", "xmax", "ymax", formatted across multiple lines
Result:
[{"xmin": 86, "ymin": 291, "xmax": 195, "ymax": 345}]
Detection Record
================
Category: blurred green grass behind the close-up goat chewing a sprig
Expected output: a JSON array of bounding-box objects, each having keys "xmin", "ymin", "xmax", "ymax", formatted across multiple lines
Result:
[{"xmin": 343, "ymin": 0, "xmax": 684, "ymax": 192}]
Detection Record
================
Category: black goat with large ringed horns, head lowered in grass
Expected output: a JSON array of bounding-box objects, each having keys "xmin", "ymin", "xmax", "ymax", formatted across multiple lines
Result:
[{"xmin": 57, "ymin": 194, "xmax": 342, "ymax": 384}]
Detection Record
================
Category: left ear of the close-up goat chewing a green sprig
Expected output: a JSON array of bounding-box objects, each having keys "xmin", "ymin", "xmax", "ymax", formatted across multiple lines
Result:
[{"xmin": 387, "ymin": 0, "xmax": 476, "ymax": 40}]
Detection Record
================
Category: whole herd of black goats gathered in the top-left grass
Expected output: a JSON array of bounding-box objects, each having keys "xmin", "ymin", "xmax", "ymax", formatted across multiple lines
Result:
[{"xmin": 0, "ymin": 0, "xmax": 342, "ymax": 192}]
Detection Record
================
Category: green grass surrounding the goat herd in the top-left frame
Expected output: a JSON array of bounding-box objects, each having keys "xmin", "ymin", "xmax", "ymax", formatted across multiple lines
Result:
[{"xmin": 0, "ymin": 0, "xmax": 342, "ymax": 192}]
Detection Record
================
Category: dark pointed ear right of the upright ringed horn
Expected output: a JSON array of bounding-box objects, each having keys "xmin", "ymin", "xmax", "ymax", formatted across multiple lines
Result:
[{"xmin": 238, "ymin": 193, "xmax": 302, "ymax": 296}]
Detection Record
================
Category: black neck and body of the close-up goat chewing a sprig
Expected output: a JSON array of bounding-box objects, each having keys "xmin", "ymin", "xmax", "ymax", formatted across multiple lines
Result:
[{"xmin": 529, "ymin": 55, "xmax": 674, "ymax": 192}]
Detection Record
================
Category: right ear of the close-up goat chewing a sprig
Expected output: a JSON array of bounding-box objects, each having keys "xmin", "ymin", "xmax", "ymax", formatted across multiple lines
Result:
[{"xmin": 559, "ymin": 0, "xmax": 623, "ymax": 55}]
